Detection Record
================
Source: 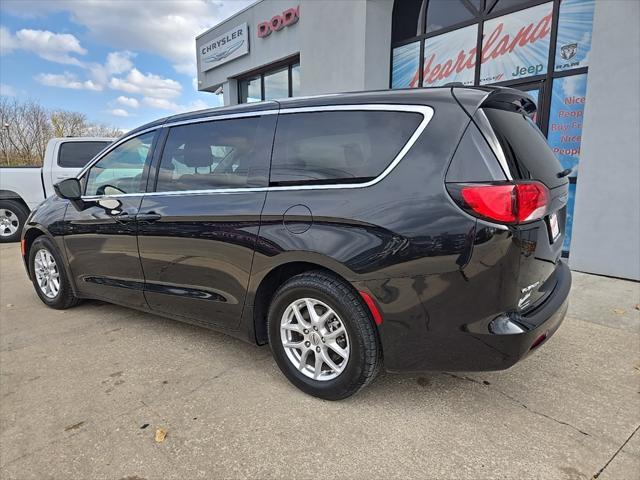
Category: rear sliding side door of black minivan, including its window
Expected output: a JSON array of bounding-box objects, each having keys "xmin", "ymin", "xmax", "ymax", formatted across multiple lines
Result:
[{"xmin": 138, "ymin": 113, "xmax": 276, "ymax": 330}]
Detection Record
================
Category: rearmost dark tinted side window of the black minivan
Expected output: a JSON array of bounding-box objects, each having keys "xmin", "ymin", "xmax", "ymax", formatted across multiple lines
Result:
[{"xmin": 271, "ymin": 111, "xmax": 422, "ymax": 185}]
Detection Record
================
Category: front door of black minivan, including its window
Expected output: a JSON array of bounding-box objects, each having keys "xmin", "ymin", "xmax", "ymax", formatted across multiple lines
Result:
[{"xmin": 64, "ymin": 132, "xmax": 155, "ymax": 308}]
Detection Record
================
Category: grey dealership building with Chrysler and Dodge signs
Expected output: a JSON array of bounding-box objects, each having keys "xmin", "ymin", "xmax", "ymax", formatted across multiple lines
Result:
[{"xmin": 196, "ymin": 0, "xmax": 640, "ymax": 280}]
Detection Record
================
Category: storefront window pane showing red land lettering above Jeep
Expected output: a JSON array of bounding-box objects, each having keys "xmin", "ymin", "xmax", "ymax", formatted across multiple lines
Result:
[{"xmin": 480, "ymin": 2, "xmax": 553, "ymax": 85}]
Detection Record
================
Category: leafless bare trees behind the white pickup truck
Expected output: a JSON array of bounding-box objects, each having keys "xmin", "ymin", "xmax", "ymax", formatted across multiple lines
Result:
[{"xmin": 0, "ymin": 96, "xmax": 123, "ymax": 166}]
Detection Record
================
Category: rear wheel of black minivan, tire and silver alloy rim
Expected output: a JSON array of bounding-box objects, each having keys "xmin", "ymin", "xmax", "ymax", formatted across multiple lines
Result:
[{"xmin": 267, "ymin": 271, "xmax": 382, "ymax": 400}]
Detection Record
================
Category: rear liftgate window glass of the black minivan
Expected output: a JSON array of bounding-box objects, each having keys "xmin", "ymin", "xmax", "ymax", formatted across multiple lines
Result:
[{"xmin": 483, "ymin": 108, "xmax": 567, "ymax": 188}]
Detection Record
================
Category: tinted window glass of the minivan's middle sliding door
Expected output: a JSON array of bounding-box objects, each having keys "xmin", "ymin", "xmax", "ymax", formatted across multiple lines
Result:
[{"xmin": 156, "ymin": 117, "xmax": 270, "ymax": 192}]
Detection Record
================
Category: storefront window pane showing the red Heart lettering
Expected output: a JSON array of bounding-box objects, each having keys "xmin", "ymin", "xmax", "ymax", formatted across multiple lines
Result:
[{"xmin": 422, "ymin": 25, "xmax": 478, "ymax": 87}]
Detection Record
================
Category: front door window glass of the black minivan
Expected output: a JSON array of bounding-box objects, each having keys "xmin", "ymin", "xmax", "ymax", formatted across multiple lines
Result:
[{"xmin": 85, "ymin": 132, "xmax": 155, "ymax": 195}]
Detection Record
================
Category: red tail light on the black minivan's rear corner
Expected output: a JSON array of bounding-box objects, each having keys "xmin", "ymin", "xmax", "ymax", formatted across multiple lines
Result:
[{"xmin": 448, "ymin": 181, "xmax": 549, "ymax": 224}]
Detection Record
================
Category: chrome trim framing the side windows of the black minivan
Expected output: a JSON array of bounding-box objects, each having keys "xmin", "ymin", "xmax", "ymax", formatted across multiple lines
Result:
[{"xmin": 77, "ymin": 103, "xmax": 434, "ymax": 201}]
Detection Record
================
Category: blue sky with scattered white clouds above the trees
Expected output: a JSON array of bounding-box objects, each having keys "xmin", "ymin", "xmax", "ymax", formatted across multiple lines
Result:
[{"xmin": 0, "ymin": 0, "xmax": 252, "ymax": 130}]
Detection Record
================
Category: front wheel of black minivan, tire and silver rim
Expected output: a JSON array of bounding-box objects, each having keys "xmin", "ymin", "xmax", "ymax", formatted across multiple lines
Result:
[{"xmin": 29, "ymin": 236, "xmax": 79, "ymax": 310}]
